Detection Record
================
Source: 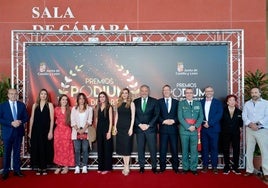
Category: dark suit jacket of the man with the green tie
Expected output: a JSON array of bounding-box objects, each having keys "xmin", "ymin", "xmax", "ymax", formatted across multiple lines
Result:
[{"xmin": 134, "ymin": 97, "xmax": 159, "ymax": 133}]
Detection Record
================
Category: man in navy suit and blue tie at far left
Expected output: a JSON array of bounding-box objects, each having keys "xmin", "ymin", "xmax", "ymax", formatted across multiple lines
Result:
[{"xmin": 0, "ymin": 89, "xmax": 29, "ymax": 180}]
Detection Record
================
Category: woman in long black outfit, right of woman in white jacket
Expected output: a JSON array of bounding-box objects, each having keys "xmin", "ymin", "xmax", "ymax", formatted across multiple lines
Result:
[{"xmin": 95, "ymin": 91, "xmax": 113, "ymax": 174}]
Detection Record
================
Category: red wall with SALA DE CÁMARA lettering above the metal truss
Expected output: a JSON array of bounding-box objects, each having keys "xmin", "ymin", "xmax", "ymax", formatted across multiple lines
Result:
[{"xmin": 0, "ymin": 0, "xmax": 266, "ymax": 76}]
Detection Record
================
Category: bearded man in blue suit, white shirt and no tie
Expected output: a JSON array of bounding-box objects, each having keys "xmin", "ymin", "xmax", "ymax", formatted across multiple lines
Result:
[{"xmin": 201, "ymin": 86, "xmax": 223, "ymax": 174}]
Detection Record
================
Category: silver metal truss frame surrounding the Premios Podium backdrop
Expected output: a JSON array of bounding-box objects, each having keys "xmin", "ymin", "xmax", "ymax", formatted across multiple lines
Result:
[{"xmin": 11, "ymin": 29, "xmax": 245, "ymax": 169}]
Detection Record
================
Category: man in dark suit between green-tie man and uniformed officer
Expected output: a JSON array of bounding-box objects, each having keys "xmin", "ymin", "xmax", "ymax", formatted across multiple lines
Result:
[{"xmin": 158, "ymin": 85, "xmax": 179, "ymax": 173}]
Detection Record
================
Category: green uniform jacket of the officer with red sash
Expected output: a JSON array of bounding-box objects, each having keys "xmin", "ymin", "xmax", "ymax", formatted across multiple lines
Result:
[{"xmin": 178, "ymin": 100, "xmax": 204, "ymax": 135}]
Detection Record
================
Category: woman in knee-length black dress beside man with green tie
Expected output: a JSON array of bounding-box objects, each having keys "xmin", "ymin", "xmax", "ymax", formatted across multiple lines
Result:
[{"xmin": 114, "ymin": 88, "xmax": 135, "ymax": 176}]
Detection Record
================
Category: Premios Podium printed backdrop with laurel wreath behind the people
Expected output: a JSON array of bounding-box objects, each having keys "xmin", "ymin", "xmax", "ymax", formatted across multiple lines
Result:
[{"xmin": 25, "ymin": 44, "xmax": 229, "ymax": 106}]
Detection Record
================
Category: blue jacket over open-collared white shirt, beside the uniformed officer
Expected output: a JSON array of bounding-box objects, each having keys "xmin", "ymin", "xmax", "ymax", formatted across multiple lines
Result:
[{"xmin": 201, "ymin": 98, "xmax": 223, "ymax": 133}]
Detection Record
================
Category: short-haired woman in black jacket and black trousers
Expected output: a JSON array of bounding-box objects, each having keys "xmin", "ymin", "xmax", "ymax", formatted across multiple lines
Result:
[{"xmin": 221, "ymin": 95, "xmax": 243, "ymax": 174}]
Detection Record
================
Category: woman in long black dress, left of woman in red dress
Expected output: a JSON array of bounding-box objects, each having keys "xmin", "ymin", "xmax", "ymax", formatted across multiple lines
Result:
[{"xmin": 28, "ymin": 89, "xmax": 54, "ymax": 175}]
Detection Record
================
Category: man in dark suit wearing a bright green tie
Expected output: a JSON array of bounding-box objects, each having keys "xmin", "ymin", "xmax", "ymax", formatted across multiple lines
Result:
[{"xmin": 134, "ymin": 85, "xmax": 159, "ymax": 174}]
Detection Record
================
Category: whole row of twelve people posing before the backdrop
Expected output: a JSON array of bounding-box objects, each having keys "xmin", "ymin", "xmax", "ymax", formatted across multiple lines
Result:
[{"xmin": 0, "ymin": 85, "xmax": 268, "ymax": 181}]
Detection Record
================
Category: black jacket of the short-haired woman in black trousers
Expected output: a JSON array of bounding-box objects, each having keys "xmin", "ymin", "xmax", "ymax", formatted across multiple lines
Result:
[{"xmin": 221, "ymin": 106, "xmax": 243, "ymax": 135}]
